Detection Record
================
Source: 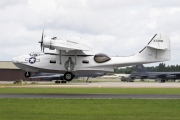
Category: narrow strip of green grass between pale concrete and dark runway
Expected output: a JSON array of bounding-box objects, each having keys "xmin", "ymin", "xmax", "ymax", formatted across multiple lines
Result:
[{"xmin": 0, "ymin": 87, "xmax": 180, "ymax": 94}]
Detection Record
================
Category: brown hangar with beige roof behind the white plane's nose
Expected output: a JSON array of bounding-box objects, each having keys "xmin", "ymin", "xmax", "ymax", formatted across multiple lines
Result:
[{"xmin": 0, "ymin": 61, "xmax": 40, "ymax": 81}]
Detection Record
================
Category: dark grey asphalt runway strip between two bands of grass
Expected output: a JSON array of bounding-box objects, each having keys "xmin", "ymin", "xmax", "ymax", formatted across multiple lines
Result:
[{"xmin": 0, "ymin": 94, "xmax": 180, "ymax": 99}]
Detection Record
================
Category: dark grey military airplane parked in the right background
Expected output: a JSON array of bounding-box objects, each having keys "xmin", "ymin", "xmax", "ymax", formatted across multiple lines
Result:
[{"xmin": 130, "ymin": 65, "xmax": 180, "ymax": 82}]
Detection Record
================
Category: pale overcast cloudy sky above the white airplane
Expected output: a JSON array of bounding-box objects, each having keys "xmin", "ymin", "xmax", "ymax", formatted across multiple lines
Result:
[{"xmin": 0, "ymin": 0, "xmax": 180, "ymax": 66}]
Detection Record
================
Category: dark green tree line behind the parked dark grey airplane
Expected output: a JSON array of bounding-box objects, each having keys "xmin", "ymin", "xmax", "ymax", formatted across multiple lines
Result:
[{"xmin": 114, "ymin": 63, "xmax": 180, "ymax": 74}]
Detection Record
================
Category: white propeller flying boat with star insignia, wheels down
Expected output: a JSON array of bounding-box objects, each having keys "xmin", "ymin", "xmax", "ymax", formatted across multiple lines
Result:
[{"xmin": 12, "ymin": 32, "xmax": 171, "ymax": 81}]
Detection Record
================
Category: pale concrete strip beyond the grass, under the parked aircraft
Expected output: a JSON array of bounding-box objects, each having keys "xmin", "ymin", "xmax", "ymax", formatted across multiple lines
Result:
[{"xmin": 0, "ymin": 82, "xmax": 180, "ymax": 88}]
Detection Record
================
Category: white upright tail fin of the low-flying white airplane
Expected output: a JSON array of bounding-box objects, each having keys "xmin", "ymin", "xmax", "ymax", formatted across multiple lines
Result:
[{"xmin": 139, "ymin": 34, "xmax": 171, "ymax": 63}]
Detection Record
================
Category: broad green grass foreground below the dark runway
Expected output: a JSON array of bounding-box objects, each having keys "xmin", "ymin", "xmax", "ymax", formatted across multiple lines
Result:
[{"xmin": 0, "ymin": 99, "xmax": 180, "ymax": 120}]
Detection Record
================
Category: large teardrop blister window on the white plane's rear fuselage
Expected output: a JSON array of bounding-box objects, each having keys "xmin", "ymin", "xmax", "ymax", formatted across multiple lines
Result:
[{"xmin": 94, "ymin": 53, "xmax": 111, "ymax": 63}]
